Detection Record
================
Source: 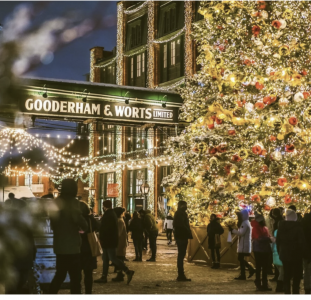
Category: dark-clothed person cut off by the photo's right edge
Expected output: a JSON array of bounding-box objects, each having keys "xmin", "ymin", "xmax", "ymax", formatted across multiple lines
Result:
[{"xmin": 302, "ymin": 213, "xmax": 311, "ymax": 294}]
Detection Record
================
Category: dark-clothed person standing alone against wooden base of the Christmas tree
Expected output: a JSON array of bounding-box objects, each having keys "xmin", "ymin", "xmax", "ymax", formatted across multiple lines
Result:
[{"xmin": 207, "ymin": 214, "xmax": 224, "ymax": 269}]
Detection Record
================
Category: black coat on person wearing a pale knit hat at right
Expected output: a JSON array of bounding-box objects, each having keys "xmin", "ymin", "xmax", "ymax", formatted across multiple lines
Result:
[{"xmin": 276, "ymin": 221, "xmax": 306, "ymax": 262}]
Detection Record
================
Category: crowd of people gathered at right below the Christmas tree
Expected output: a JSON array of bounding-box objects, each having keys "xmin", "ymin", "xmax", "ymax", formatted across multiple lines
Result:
[{"xmin": 207, "ymin": 205, "xmax": 311, "ymax": 294}]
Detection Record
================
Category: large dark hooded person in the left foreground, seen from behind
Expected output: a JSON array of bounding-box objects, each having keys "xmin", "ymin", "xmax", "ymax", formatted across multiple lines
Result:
[{"xmin": 49, "ymin": 178, "xmax": 88, "ymax": 294}]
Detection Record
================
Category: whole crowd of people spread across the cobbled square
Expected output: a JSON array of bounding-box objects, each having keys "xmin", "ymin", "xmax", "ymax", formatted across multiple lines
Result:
[{"xmin": 5, "ymin": 179, "xmax": 311, "ymax": 294}]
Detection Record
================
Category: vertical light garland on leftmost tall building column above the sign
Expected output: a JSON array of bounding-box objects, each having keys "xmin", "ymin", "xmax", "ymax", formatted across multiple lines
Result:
[{"xmin": 116, "ymin": 2, "xmax": 124, "ymax": 85}]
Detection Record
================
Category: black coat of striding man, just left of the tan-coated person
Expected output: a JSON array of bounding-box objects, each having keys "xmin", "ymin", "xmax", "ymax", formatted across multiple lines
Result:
[{"xmin": 99, "ymin": 209, "xmax": 119, "ymax": 249}]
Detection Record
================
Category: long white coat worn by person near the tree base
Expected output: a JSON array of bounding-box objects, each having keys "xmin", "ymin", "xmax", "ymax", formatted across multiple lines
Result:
[{"xmin": 232, "ymin": 209, "xmax": 252, "ymax": 253}]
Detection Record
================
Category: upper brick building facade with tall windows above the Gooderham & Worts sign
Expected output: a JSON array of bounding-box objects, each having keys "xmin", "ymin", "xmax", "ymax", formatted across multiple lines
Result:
[{"xmin": 90, "ymin": 1, "xmax": 203, "ymax": 90}]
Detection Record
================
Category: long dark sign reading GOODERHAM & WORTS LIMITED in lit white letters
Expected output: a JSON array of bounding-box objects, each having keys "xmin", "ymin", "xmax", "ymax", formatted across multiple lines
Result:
[{"xmin": 20, "ymin": 97, "xmax": 179, "ymax": 123}]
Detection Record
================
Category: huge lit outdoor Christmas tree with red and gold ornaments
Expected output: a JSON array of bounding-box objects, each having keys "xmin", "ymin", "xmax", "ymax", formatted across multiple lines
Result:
[{"xmin": 163, "ymin": 1, "xmax": 311, "ymax": 222}]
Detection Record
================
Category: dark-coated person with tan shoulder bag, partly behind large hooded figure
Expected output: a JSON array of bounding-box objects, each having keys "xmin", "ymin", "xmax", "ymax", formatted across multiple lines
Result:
[{"xmin": 80, "ymin": 200, "xmax": 99, "ymax": 294}]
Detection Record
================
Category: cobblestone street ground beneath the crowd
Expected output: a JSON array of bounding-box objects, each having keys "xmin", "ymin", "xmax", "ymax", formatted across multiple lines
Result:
[{"xmin": 60, "ymin": 234, "xmax": 303, "ymax": 294}]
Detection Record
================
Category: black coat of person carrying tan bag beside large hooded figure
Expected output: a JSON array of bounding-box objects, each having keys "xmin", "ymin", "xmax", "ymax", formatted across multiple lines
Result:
[{"xmin": 80, "ymin": 215, "xmax": 99, "ymax": 270}]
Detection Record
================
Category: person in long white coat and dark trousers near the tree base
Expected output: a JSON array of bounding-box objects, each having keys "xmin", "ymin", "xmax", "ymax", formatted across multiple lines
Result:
[{"xmin": 229, "ymin": 209, "xmax": 255, "ymax": 280}]
